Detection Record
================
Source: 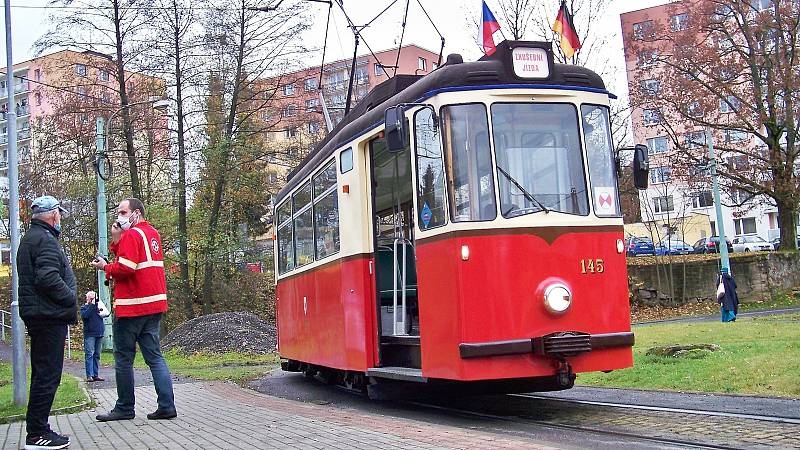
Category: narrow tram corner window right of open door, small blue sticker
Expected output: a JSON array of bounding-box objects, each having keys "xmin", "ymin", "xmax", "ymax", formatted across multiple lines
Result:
[{"xmin": 414, "ymin": 108, "xmax": 447, "ymax": 230}]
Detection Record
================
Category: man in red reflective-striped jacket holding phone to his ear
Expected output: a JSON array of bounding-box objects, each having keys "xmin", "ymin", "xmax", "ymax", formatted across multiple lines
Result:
[{"xmin": 91, "ymin": 198, "xmax": 178, "ymax": 422}]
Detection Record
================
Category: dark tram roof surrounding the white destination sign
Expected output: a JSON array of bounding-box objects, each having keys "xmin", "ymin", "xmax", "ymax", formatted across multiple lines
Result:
[{"xmin": 277, "ymin": 41, "xmax": 611, "ymax": 201}]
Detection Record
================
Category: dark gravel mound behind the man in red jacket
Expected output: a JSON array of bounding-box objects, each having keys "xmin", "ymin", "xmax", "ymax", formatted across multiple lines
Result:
[{"xmin": 161, "ymin": 312, "xmax": 278, "ymax": 354}]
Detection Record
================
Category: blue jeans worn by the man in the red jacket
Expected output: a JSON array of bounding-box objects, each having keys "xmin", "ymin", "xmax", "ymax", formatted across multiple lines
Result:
[{"xmin": 114, "ymin": 313, "xmax": 175, "ymax": 414}]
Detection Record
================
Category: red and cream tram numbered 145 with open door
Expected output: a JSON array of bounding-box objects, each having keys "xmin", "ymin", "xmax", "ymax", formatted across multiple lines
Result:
[{"xmin": 274, "ymin": 42, "xmax": 647, "ymax": 397}]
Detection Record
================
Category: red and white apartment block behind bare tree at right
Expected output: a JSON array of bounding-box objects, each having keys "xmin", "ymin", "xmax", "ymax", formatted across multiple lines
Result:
[{"xmin": 620, "ymin": 0, "xmax": 780, "ymax": 244}]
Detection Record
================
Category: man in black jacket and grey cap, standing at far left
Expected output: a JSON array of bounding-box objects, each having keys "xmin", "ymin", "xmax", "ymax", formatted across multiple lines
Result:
[{"xmin": 17, "ymin": 195, "xmax": 78, "ymax": 449}]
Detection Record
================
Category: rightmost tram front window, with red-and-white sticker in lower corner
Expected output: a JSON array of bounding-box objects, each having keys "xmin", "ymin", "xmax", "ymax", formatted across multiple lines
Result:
[{"xmin": 581, "ymin": 105, "xmax": 622, "ymax": 217}]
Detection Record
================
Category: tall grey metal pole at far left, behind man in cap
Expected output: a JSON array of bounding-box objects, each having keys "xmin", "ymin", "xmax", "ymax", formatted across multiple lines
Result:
[{"xmin": 5, "ymin": 0, "xmax": 28, "ymax": 406}]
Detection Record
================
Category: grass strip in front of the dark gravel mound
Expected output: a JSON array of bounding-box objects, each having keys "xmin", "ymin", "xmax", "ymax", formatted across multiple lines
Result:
[{"xmin": 73, "ymin": 351, "xmax": 280, "ymax": 383}]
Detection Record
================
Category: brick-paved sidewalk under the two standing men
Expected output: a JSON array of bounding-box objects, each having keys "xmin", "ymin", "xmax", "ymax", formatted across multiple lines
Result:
[{"xmin": 0, "ymin": 382, "xmax": 547, "ymax": 450}]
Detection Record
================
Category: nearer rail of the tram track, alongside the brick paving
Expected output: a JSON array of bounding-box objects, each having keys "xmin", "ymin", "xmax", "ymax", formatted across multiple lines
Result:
[{"xmin": 402, "ymin": 401, "xmax": 747, "ymax": 450}]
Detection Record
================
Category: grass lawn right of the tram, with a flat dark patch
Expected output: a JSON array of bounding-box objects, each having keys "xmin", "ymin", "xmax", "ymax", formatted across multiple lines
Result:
[{"xmin": 577, "ymin": 314, "xmax": 800, "ymax": 397}]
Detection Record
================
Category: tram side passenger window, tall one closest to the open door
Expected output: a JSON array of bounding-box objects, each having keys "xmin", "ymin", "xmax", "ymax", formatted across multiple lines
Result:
[{"xmin": 312, "ymin": 160, "xmax": 339, "ymax": 259}]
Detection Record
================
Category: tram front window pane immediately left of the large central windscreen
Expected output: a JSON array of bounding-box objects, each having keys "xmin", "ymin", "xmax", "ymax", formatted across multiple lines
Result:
[{"xmin": 442, "ymin": 104, "xmax": 497, "ymax": 222}]
